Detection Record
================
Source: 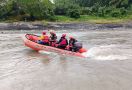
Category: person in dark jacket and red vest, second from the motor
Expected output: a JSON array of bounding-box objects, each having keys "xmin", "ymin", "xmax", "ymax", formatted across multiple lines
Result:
[{"xmin": 57, "ymin": 34, "xmax": 68, "ymax": 49}]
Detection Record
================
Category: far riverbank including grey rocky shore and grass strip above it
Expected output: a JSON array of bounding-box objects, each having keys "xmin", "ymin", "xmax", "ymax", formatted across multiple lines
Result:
[{"xmin": 0, "ymin": 15, "xmax": 132, "ymax": 30}]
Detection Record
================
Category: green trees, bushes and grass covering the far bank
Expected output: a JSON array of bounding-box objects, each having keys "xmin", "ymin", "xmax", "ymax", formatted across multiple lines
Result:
[{"xmin": 0, "ymin": 0, "xmax": 132, "ymax": 23}]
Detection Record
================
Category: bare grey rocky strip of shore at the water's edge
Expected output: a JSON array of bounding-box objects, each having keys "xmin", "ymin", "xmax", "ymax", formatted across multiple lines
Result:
[{"xmin": 0, "ymin": 21, "xmax": 132, "ymax": 30}]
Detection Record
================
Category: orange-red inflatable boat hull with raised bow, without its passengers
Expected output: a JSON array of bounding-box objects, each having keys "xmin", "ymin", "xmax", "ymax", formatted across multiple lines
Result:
[{"xmin": 23, "ymin": 34, "xmax": 87, "ymax": 57}]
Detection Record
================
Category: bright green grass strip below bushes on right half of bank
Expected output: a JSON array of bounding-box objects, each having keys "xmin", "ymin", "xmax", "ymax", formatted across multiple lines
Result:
[{"xmin": 55, "ymin": 15, "xmax": 132, "ymax": 24}]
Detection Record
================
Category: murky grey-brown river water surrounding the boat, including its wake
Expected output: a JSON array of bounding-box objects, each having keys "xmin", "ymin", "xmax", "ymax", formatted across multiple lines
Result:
[{"xmin": 0, "ymin": 29, "xmax": 132, "ymax": 90}]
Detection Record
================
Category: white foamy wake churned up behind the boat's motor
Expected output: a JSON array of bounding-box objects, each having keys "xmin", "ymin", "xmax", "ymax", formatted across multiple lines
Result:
[{"xmin": 83, "ymin": 45, "xmax": 132, "ymax": 60}]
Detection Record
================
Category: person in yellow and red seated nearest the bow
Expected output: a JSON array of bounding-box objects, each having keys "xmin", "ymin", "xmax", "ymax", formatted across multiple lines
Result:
[{"xmin": 38, "ymin": 31, "xmax": 49, "ymax": 45}]
